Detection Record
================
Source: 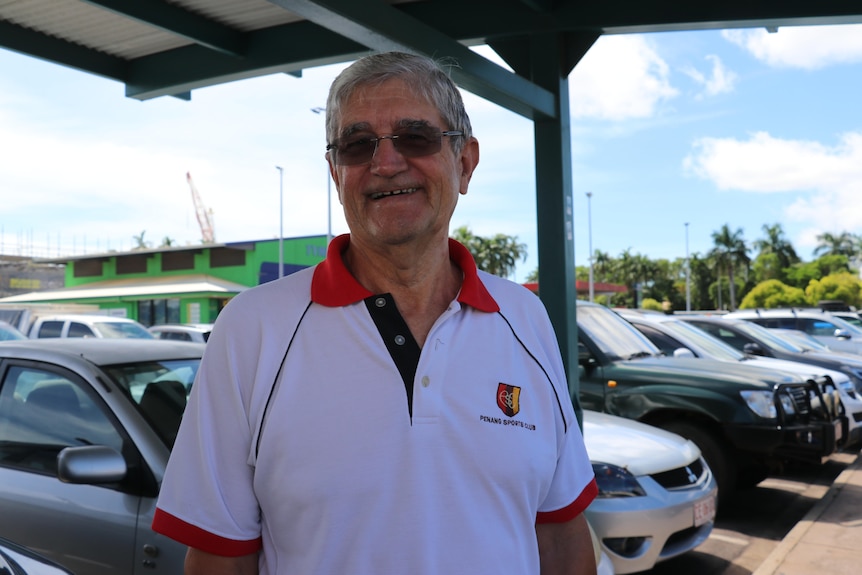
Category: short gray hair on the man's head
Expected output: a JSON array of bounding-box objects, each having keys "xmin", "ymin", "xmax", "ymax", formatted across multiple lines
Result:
[{"xmin": 326, "ymin": 52, "xmax": 473, "ymax": 154}]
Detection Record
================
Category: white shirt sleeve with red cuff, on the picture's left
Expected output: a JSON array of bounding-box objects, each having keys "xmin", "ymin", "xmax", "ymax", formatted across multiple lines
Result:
[{"xmin": 152, "ymin": 292, "xmax": 261, "ymax": 555}]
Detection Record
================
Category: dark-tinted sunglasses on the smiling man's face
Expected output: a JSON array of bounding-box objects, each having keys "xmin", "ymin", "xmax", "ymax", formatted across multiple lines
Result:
[{"xmin": 326, "ymin": 126, "xmax": 464, "ymax": 166}]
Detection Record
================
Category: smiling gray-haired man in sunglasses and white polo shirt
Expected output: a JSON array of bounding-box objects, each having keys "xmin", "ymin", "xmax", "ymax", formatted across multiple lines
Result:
[{"xmin": 154, "ymin": 53, "xmax": 597, "ymax": 575}]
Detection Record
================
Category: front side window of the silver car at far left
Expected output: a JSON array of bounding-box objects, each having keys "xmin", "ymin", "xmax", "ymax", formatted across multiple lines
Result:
[{"xmin": 0, "ymin": 366, "xmax": 123, "ymax": 474}]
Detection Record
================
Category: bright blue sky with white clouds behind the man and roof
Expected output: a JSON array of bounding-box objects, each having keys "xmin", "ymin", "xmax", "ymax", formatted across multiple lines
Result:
[{"xmin": 0, "ymin": 25, "xmax": 862, "ymax": 281}]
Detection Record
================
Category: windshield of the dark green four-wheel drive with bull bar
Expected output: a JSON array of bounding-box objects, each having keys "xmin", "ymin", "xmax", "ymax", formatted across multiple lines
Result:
[{"xmin": 578, "ymin": 305, "xmax": 661, "ymax": 359}]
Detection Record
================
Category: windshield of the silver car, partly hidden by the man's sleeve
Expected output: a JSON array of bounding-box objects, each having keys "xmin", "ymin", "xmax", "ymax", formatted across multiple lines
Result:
[{"xmin": 102, "ymin": 359, "xmax": 200, "ymax": 447}]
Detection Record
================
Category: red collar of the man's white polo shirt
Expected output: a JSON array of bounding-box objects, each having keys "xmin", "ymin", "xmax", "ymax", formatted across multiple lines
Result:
[{"xmin": 311, "ymin": 234, "xmax": 500, "ymax": 313}]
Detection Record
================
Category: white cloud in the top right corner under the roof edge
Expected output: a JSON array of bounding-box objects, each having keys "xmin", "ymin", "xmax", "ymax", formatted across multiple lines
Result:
[{"xmin": 722, "ymin": 25, "xmax": 862, "ymax": 70}]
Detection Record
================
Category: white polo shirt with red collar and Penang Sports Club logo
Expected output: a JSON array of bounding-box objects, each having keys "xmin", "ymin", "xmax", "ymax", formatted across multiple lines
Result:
[{"xmin": 153, "ymin": 235, "xmax": 597, "ymax": 575}]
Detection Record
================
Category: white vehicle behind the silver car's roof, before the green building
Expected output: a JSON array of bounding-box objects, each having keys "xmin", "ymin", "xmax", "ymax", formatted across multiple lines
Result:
[{"xmin": 29, "ymin": 314, "xmax": 153, "ymax": 339}]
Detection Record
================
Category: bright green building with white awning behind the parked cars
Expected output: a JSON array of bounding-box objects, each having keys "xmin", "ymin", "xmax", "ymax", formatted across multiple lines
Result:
[{"xmin": 0, "ymin": 235, "xmax": 327, "ymax": 326}]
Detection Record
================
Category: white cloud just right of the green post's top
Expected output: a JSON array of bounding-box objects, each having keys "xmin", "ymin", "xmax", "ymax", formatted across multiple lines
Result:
[{"xmin": 569, "ymin": 36, "xmax": 678, "ymax": 121}]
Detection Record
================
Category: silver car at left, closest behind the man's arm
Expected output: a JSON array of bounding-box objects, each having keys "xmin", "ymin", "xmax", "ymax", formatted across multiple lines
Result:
[{"xmin": 0, "ymin": 338, "xmax": 204, "ymax": 575}]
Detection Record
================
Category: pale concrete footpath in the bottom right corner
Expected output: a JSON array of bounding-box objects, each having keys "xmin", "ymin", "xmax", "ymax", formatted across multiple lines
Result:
[{"xmin": 752, "ymin": 453, "xmax": 862, "ymax": 575}]
